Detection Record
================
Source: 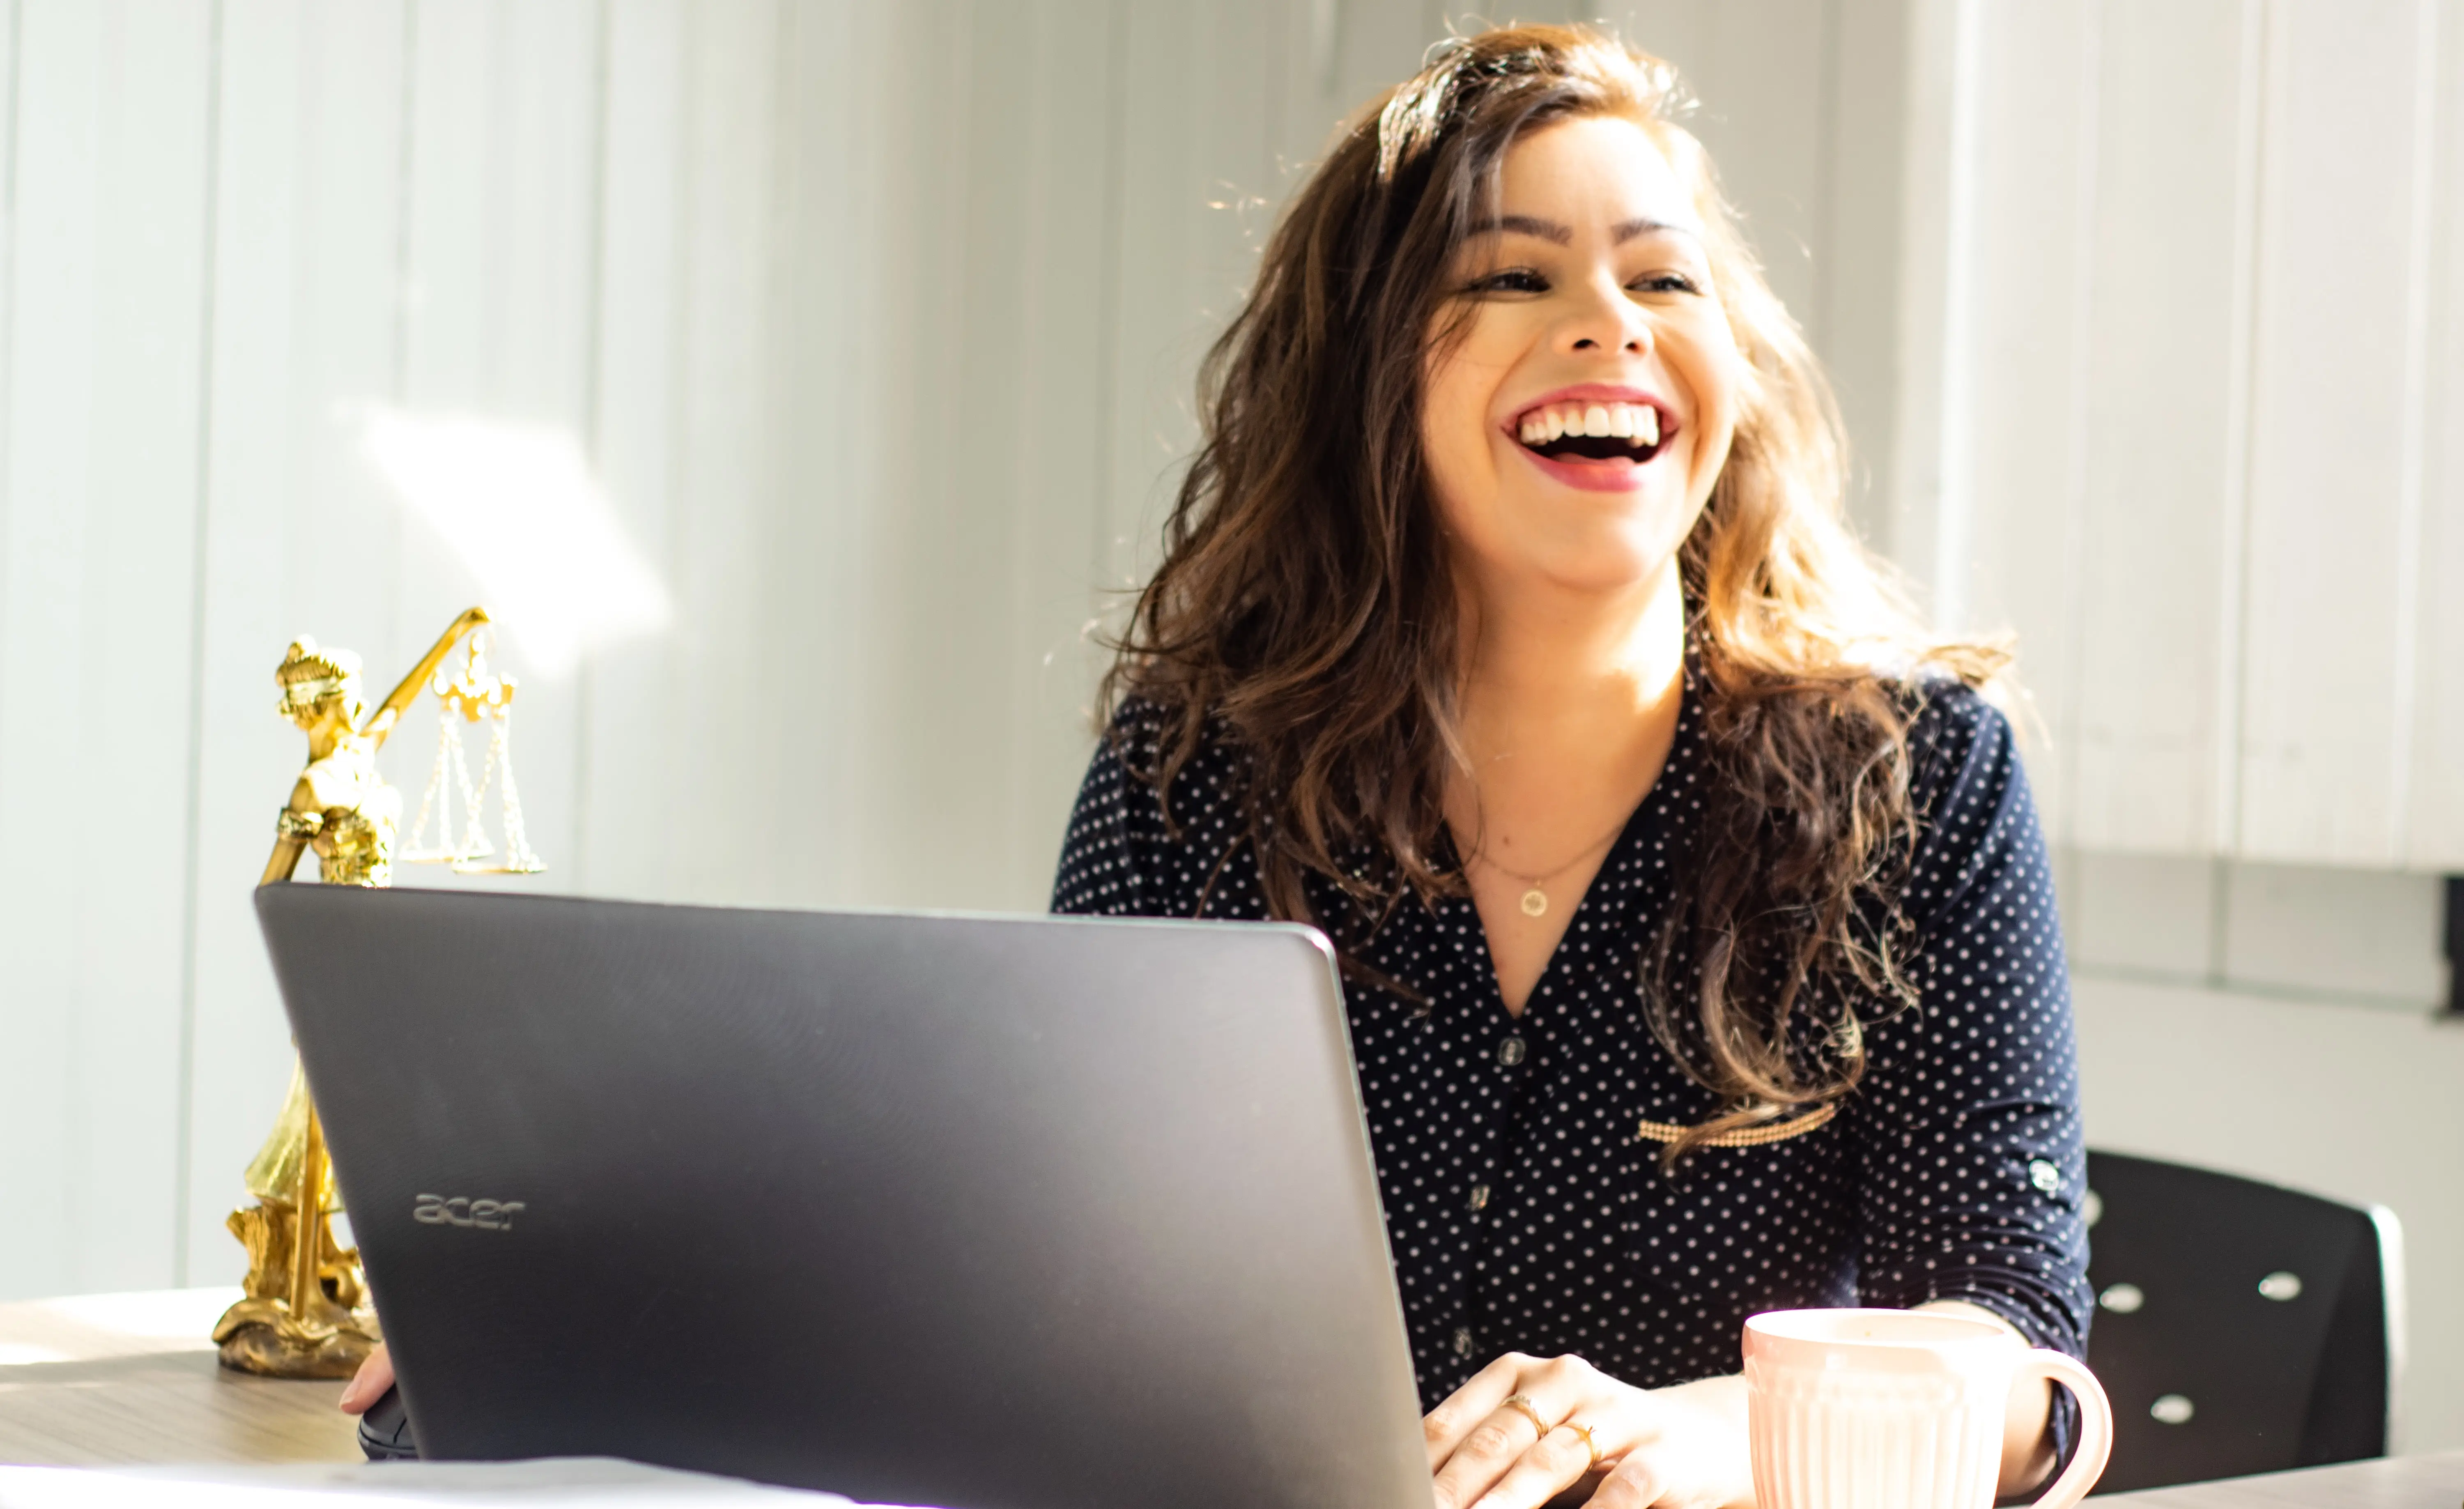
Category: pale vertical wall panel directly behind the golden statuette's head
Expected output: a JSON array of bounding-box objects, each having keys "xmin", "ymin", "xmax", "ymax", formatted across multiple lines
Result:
[{"xmin": 182, "ymin": 0, "xmax": 416, "ymax": 1282}]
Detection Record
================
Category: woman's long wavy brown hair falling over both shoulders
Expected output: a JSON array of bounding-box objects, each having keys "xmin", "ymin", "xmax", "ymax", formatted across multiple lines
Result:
[{"xmin": 1104, "ymin": 27, "xmax": 2003, "ymax": 1162}]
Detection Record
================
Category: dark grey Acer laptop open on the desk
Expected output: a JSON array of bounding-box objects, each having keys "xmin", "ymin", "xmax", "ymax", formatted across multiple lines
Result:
[{"xmin": 256, "ymin": 885, "xmax": 1429, "ymax": 1509}]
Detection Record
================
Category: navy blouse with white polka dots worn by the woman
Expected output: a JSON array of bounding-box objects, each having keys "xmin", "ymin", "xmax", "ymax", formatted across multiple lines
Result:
[{"xmin": 1052, "ymin": 676, "xmax": 2089, "ymax": 1410}]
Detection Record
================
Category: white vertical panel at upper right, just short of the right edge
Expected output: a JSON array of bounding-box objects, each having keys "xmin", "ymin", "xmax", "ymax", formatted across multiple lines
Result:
[{"xmin": 2240, "ymin": 0, "xmax": 2432, "ymax": 863}]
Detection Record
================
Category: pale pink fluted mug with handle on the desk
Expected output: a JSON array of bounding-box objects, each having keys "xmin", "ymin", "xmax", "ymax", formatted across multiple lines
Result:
[{"xmin": 1745, "ymin": 1309, "xmax": 2114, "ymax": 1509}]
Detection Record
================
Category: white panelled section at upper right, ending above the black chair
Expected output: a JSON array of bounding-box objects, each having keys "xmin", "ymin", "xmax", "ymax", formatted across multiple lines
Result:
[{"xmin": 1892, "ymin": 0, "xmax": 2464, "ymax": 870}]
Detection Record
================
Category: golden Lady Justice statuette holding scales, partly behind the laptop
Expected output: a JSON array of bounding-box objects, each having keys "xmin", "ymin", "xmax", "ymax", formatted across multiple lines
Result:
[{"xmin": 214, "ymin": 609, "xmax": 547, "ymax": 1378}]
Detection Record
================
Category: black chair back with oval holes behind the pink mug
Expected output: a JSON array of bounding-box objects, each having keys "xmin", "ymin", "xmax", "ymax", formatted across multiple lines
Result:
[{"xmin": 2087, "ymin": 1152, "xmax": 2405, "ymax": 1492}]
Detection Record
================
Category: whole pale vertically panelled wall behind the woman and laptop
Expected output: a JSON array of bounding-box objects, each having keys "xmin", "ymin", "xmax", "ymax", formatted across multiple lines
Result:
[{"xmin": 0, "ymin": 0, "xmax": 2464, "ymax": 1445}]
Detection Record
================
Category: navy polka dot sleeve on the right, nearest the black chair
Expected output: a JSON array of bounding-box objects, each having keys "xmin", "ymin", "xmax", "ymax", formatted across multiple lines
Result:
[{"xmin": 1846, "ymin": 685, "xmax": 2089, "ymax": 1356}]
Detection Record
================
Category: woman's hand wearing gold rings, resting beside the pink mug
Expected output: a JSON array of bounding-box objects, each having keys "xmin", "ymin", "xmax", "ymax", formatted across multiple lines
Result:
[{"xmin": 1422, "ymin": 1351, "xmax": 1754, "ymax": 1509}]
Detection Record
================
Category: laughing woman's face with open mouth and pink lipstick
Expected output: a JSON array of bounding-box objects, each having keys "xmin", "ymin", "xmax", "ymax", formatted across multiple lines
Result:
[{"xmin": 1419, "ymin": 116, "xmax": 1747, "ymax": 604}]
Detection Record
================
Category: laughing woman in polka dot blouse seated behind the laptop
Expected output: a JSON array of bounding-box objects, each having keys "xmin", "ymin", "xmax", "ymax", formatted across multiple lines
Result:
[{"xmin": 1055, "ymin": 27, "xmax": 2087, "ymax": 1509}]
